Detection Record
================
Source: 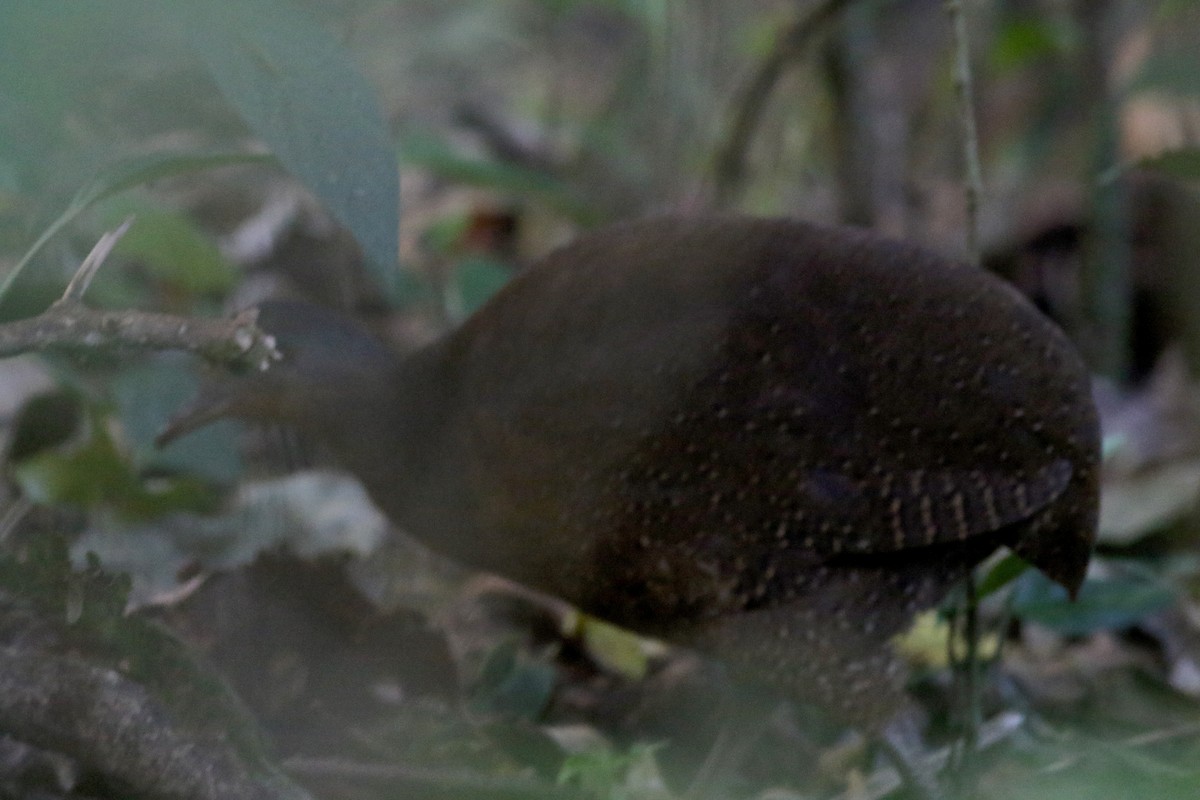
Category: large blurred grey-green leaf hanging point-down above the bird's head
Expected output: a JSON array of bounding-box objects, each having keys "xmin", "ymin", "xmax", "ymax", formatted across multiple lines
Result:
[{"xmin": 188, "ymin": 0, "xmax": 400, "ymax": 291}]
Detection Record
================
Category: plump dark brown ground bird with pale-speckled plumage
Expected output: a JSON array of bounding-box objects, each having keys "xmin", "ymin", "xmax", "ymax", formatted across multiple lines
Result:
[{"xmin": 166, "ymin": 217, "xmax": 1099, "ymax": 796}]
